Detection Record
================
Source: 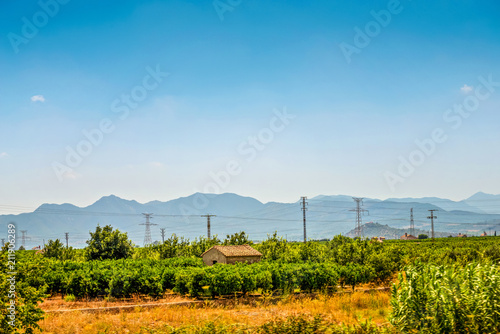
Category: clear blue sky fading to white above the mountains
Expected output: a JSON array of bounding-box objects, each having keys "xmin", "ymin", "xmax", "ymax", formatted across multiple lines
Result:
[{"xmin": 0, "ymin": 0, "xmax": 500, "ymax": 211}]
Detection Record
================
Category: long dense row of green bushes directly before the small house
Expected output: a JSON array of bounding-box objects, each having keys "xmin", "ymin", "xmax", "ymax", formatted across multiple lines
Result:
[{"xmin": 24, "ymin": 258, "xmax": 375, "ymax": 298}]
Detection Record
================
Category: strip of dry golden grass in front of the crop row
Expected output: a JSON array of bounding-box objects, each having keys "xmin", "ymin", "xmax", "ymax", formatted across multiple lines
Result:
[{"xmin": 39, "ymin": 292, "xmax": 390, "ymax": 334}]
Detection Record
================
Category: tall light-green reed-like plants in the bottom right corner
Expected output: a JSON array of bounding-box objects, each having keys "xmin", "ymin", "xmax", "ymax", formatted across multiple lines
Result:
[{"xmin": 390, "ymin": 264, "xmax": 500, "ymax": 334}]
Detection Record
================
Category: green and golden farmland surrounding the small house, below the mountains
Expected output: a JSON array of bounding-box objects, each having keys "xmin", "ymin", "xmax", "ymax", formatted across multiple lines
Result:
[{"xmin": 2, "ymin": 233, "xmax": 500, "ymax": 333}]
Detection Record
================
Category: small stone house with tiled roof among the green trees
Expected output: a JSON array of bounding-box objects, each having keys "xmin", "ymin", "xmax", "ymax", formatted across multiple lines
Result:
[{"xmin": 201, "ymin": 245, "xmax": 262, "ymax": 266}]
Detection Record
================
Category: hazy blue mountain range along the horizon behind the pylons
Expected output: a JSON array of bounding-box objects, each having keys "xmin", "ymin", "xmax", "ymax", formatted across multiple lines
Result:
[{"xmin": 0, "ymin": 193, "xmax": 500, "ymax": 248}]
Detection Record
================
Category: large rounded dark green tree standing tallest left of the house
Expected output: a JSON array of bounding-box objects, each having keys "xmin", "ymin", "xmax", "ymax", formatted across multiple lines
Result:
[{"xmin": 85, "ymin": 225, "xmax": 133, "ymax": 260}]
